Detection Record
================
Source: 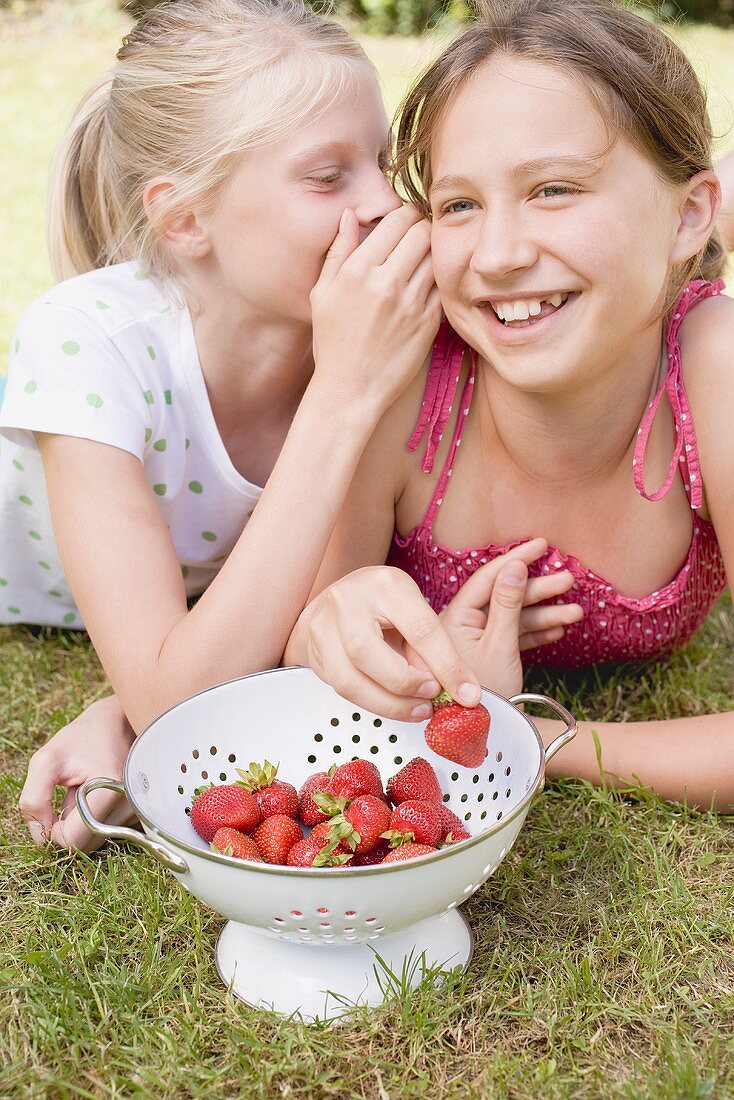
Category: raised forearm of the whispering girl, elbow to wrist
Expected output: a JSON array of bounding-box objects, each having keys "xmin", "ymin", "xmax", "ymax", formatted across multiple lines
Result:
[{"xmin": 130, "ymin": 392, "xmax": 379, "ymax": 728}]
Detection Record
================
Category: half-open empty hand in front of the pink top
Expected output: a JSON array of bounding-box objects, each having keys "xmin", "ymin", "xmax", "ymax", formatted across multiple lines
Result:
[{"xmin": 440, "ymin": 539, "xmax": 583, "ymax": 696}]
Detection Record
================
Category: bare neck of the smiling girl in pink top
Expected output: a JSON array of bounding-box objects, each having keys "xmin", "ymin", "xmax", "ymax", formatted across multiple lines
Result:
[{"xmin": 478, "ymin": 327, "xmax": 661, "ymax": 488}]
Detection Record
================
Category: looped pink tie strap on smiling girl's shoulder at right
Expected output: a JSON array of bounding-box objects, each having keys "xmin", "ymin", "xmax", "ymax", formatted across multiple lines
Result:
[{"xmin": 632, "ymin": 279, "xmax": 724, "ymax": 508}]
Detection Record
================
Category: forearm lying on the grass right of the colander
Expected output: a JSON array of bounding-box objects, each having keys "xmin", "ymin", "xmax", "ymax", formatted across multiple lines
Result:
[{"xmin": 534, "ymin": 713, "xmax": 734, "ymax": 813}]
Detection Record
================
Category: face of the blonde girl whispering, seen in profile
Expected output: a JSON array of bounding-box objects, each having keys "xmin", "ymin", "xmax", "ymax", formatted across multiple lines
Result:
[{"xmin": 201, "ymin": 66, "xmax": 401, "ymax": 325}]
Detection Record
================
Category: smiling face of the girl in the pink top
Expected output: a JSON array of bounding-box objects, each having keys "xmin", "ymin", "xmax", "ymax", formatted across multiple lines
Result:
[{"xmin": 429, "ymin": 56, "xmax": 680, "ymax": 393}]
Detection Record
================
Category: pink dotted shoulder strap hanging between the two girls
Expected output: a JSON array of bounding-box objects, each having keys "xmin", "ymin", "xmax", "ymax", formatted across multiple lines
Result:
[{"xmin": 408, "ymin": 320, "xmax": 476, "ymax": 529}]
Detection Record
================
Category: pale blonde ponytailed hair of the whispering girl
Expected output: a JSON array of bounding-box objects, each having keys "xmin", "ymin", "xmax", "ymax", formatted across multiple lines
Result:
[{"xmin": 48, "ymin": 0, "xmax": 371, "ymax": 278}]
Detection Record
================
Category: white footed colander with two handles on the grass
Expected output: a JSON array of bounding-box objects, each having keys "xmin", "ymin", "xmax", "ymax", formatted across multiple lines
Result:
[{"xmin": 77, "ymin": 669, "xmax": 577, "ymax": 1020}]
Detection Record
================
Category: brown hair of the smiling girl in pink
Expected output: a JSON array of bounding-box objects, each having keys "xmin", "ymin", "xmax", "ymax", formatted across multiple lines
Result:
[{"xmin": 396, "ymin": 0, "xmax": 725, "ymax": 299}]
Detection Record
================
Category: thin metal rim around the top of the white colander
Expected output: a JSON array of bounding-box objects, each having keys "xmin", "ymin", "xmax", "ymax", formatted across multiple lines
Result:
[{"xmin": 123, "ymin": 664, "xmax": 546, "ymax": 881}]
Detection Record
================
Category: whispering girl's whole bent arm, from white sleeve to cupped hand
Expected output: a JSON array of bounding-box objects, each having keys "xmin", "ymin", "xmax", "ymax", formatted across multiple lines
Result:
[{"xmin": 40, "ymin": 208, "xmax": 440, "ymax": 729}]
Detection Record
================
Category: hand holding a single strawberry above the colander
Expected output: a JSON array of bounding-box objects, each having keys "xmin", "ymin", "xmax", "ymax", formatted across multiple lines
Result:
[{"xmin": 286, "ymin": 565, "xmax": 481, "ymax": 722}]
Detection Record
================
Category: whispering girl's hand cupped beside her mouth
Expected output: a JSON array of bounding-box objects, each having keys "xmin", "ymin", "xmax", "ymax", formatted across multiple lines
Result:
[{"xmin": 311, "ymin": 206, "xmax": 441, "ymax": 415}]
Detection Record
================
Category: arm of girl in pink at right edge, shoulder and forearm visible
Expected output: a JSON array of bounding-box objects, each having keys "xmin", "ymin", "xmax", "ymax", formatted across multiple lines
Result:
[{"xmin": 538, "ymin": 298, "xmax": 734, "ymax": 812}]
